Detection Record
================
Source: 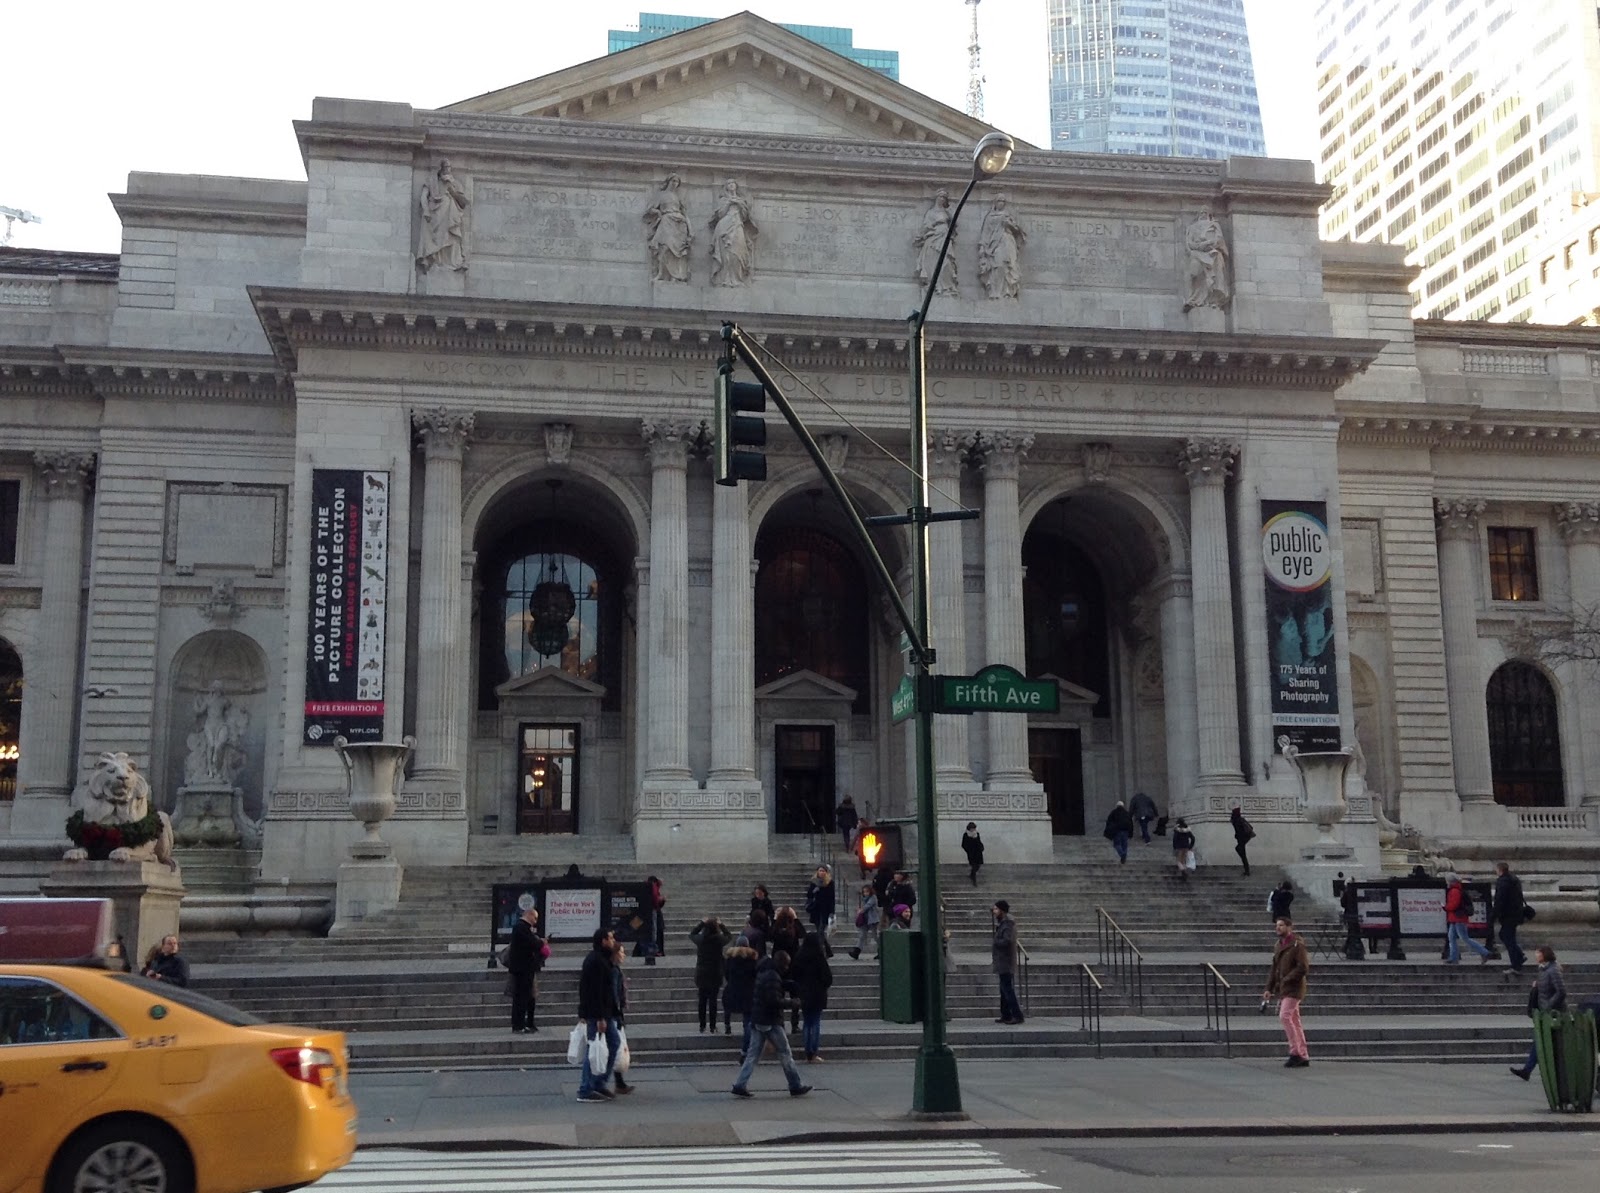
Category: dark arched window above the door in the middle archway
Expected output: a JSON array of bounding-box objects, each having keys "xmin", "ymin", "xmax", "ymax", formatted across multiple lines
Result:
[{"xmin": 755, "ymin": 526, "xmax": 872, "ymax": 715}]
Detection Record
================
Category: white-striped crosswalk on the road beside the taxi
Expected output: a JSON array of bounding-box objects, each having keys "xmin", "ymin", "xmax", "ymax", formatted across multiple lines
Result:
[{"xmin": 317, "ymin": 1142, "xmax": 1058, "ymax": 1193}]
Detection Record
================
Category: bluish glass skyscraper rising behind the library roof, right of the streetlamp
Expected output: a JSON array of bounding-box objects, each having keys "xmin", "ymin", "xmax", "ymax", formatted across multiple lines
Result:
[{"xmin": 1048, "ymin": 0, "xmax": 1267, "ymax": 157}]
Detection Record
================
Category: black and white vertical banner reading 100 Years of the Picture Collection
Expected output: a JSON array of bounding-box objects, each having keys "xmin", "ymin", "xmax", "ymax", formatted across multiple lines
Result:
[{"xmin": 304, "ymin": 469, "xmax": 389, "ymax": 745}]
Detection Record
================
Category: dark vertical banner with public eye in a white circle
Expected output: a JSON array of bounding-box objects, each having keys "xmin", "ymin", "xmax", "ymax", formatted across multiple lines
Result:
[{"xmin": 1261, "ymin": 501, "xmax": 1339, "ymax": 752}]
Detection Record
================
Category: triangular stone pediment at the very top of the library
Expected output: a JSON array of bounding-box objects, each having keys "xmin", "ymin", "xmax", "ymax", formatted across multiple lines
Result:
[{"xmin": 445, "ymin": 13, "xmax": 1011, "ymax": 146}]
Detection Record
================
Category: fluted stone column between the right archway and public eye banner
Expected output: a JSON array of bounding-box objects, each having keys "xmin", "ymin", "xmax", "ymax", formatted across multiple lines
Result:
[{"xmin": 1178, "ymin": 440, "xmax": 1245, "ymax": 785}]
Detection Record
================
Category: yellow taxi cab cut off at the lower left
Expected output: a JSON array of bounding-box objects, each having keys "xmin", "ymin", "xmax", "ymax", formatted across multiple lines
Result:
[{"xmin": 0, "ymin": 940, "xmax": 355, "ymax": 1193}]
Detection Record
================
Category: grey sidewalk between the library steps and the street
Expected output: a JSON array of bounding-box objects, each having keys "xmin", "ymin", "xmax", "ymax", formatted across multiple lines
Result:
[{"xmin": 350, "ymin": 1041, "xmax": 1600, "ymax": 1148}]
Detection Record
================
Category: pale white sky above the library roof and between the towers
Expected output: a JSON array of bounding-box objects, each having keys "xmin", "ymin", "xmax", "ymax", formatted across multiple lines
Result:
[{"xmin": 0, "ymin": 0, "xmax": 1315, "ymax": 253}]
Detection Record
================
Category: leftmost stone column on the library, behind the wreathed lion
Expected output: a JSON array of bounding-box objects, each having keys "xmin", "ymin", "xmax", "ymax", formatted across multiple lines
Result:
[{"xmin": 11, "ymin": 451, "xmax": 94, "ymax": 838}]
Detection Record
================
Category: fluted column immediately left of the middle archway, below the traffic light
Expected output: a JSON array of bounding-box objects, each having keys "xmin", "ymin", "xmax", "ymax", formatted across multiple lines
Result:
[{"xmin": 709, "ymin": 485, "xmax": 755, "ymax": 785}]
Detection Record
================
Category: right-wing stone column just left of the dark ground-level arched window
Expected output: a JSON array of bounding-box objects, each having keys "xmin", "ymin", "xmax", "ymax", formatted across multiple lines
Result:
[{"xmin": 1434, "ymin": 497, "xmax": 1494, "ymax": 803}]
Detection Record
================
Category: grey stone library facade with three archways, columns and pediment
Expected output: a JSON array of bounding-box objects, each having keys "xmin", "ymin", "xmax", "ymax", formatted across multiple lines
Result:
[{"xmin": 0, "ymin": 14, "xmax": 1600, "ymax": 884}]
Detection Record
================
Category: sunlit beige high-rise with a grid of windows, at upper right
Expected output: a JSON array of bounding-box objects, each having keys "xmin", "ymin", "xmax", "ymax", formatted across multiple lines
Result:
[{"xmin": 1315, "ymin": 0, "xmax": 1600, "ymax": 323}]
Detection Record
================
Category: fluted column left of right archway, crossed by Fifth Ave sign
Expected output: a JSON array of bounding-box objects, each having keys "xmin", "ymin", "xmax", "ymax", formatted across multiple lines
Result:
[{"xmin": 978, "ymin": 430, "xmax": 1035, "ymax": 788}]
